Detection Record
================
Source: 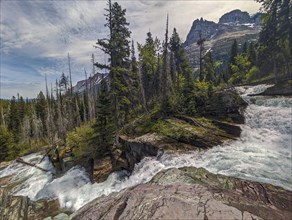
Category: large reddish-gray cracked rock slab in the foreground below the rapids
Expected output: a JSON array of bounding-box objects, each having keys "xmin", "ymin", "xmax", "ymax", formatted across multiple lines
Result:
[{"xmin": 71, "ymin": 167, "xmax": 292, "ymax": 220}]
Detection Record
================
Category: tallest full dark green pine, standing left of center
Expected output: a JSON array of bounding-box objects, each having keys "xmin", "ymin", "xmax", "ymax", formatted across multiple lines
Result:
[{"xmin": 96, "ymin": 0, "xmax": 131, "ymax": 142}]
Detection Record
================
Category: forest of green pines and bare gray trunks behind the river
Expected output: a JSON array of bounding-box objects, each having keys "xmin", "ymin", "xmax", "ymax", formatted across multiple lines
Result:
[{"xmin": 0, "ymin": 0, "xmax": 292, "ymax": 160}]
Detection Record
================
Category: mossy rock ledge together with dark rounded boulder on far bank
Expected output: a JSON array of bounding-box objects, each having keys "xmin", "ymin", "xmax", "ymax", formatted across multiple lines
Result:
[{"xmin": 108, "ymin": 89, "xmax": 247, "ymax": 180}]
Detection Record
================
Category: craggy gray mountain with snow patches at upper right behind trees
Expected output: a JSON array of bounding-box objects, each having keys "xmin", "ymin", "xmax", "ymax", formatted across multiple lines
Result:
[{"xmin": 184, "ymin": 9, "xmax": 262, "ymax": 66}]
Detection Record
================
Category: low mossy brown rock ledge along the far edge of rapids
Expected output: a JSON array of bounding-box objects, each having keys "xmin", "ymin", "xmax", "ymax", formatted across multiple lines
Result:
[{"xmin": 116, "ymin": 116, "xmax": 241, "ymax": 174}]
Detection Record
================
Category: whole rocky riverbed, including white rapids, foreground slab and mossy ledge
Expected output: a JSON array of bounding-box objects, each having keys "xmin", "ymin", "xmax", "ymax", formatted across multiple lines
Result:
[{"xmin": 0, "ymin": 86, "xmax": 292, "ymax": 220}]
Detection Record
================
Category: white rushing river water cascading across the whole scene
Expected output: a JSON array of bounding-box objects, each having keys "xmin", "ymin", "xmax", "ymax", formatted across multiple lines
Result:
[{"xmin": 0, "ymin": 85, "xmax": 292, "ymax": 210}]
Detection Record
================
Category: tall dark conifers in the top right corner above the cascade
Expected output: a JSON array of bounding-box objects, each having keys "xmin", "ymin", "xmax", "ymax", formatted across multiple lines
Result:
[{"xmin": 257, "ymin": 0, "xmax": 292, "ymax": 78}]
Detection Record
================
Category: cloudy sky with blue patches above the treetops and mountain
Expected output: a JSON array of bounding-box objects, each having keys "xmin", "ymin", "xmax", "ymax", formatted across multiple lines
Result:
[{"xmin": 0, "ymin": 0, "xmax": 260, "ymax": 98}]
